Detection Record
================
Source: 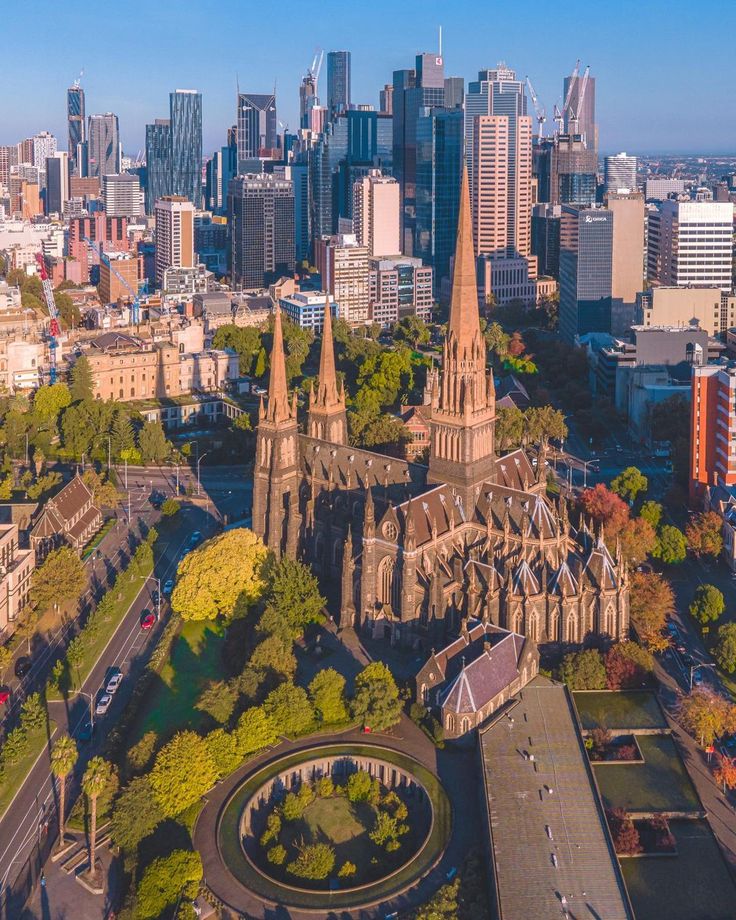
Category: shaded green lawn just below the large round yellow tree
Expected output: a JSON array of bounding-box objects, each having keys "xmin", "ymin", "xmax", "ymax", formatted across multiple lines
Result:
[{"xmin": 131, "ymin": 620, "xmax": 225, "ymax": 744}]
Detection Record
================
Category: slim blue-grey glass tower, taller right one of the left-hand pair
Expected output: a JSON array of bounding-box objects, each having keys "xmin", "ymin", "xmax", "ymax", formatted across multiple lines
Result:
[{"xmin": 169, "ymin": 89, "xmax": 202, "ymax": 208}]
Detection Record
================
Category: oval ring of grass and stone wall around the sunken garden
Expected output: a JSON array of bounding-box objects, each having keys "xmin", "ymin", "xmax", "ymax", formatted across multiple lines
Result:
[{"xmin": 217, "ymin": 744, "xmax": 452, "ymax": 915}]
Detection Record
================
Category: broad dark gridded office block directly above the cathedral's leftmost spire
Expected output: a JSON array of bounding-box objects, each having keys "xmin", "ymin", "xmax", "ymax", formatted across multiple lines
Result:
[{"xmin": 227, "ymin": 174, "xmax": 294, "ymax": 288}]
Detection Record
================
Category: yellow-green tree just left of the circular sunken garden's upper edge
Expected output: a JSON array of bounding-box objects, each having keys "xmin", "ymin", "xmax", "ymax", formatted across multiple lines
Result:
[{"xmin": 150, "ymin": 731, "xmax": 218, "ymax": 818}]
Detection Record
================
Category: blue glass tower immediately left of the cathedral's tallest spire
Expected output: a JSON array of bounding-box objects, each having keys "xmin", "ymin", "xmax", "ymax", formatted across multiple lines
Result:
[{"xmin": 414, "ymin": 109, "xmax": 464, "ymax": 291}]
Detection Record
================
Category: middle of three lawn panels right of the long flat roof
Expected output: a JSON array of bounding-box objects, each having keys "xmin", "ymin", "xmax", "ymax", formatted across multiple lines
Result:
[{"xmin": 593, "ymin": 735, "xmax": 701, "ymax": 811}]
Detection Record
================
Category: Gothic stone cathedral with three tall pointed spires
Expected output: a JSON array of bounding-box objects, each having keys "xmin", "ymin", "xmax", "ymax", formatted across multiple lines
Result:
[{"xmin": 253, "ymin": 169, "xmax": 629, "ymax": 649}]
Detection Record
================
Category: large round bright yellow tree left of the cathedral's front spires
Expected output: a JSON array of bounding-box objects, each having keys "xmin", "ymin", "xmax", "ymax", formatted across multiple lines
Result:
[{"xmin": 171, "ymin": 527, "xmax": 268, "ymax": 620}]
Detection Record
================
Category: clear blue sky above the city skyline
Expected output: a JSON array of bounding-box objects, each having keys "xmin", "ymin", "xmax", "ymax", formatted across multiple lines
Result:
[{"xmin": 0, "ymin": 0, "xmax": 736, "ymax": 155}]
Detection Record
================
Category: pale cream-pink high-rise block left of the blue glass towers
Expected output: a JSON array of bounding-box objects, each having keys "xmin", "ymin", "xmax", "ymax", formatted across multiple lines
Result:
[{"xmin": 353, "ymin": 169, "xmax": 401, "ymax": 258}]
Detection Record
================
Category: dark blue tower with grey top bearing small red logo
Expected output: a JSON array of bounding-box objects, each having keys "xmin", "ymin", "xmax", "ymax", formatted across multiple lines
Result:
[{"xmin": 393, "ymin": 52, "xmax": 445, "ymax": 255}]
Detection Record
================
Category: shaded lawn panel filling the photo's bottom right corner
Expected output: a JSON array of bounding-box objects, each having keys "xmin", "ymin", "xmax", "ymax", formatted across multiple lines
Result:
[{"xmin": 621, "ymin": 821, "xmax": 736, "ymax": 920}]
